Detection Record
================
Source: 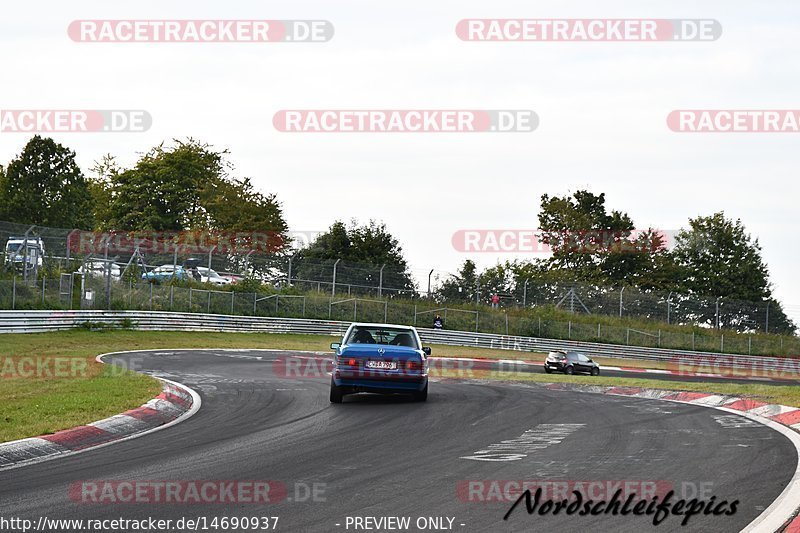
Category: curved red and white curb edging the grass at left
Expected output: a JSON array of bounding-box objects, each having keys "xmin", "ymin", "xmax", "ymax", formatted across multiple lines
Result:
[{"xmin": 0, "ymin": 354, "xmax": 201, "ymax": 470}]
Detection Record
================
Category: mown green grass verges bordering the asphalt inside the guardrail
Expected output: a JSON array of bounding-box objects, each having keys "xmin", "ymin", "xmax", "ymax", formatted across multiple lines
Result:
[{"xmin": 0, "ymin": 330, "xmax": 800, "ymax": 442}]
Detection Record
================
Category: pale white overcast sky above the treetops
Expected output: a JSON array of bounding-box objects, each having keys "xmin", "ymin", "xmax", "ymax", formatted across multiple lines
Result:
[{"xmin": 0, "ymin": 0, "xmax": 800, "ymax": 318}]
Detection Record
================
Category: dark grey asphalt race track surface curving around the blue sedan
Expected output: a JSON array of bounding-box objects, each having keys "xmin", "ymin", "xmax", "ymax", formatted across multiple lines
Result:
[{"xmin": 0, "ymin": 350, "xmax": 798, "ymax": 532}]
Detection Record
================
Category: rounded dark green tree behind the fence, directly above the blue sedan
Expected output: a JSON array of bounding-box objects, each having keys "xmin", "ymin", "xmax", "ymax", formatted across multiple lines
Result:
[{"xmin": 293, "ymin": 220, "xmax": 416, "ymax": 292}]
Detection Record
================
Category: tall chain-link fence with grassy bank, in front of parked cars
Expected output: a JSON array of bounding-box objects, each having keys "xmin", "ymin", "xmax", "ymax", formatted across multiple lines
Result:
[{"xmin": 0, "ymin": 218, "xmax": 800, "ymax": 355}]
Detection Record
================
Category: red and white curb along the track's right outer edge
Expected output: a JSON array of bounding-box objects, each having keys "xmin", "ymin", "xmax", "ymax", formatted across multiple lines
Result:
[{"xmin": 524, "ymin": 383, "xmax": 800, "ymax": 533}]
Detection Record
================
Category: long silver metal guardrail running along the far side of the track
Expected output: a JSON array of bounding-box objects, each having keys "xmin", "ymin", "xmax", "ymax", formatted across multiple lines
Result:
[{"xmin": 0, "ymin": 310, "xmax": 797, "ymax": 370}]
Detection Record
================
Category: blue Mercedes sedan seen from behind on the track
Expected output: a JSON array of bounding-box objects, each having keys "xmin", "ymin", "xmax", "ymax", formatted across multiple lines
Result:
[{"xmin": 330, "ymin": 324, "xmax": 431, "ymax": 403}]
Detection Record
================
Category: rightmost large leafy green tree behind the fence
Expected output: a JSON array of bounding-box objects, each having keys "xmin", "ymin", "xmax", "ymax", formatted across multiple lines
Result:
[{"xmin": 674, "ymin": 211, "xmax": 795, "ymax": 332}]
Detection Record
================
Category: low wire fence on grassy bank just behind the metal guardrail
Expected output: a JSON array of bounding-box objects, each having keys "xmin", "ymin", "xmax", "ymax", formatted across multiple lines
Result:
[{"xmin": 0, "ymin": 274, "xmax": 800, "ymax": 355}]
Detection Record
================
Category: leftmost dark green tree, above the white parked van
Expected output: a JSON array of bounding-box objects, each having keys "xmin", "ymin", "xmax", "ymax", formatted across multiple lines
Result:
[{"xmin": 0, "ymin": 135, "xmax": 94, "ymax": 229}]
